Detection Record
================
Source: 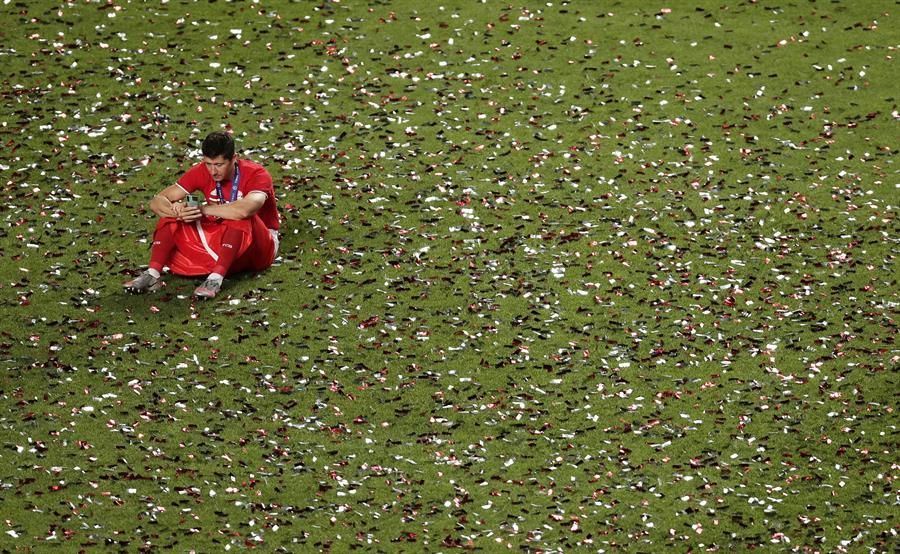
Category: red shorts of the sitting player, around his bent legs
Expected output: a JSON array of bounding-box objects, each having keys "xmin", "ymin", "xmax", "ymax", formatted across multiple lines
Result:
[{"xmin": 156, "ymin": 215, "xmax": 278, "ymax": 276}]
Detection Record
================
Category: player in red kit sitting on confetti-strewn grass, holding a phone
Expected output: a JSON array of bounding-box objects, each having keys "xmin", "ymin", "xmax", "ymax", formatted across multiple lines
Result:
[{"xmin": 124, "ymin": 132, "xmax": 279, "ymax": 298}]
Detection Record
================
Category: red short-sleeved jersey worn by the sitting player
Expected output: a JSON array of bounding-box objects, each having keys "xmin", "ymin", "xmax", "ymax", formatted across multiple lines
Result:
[{"xmin": 178, "ymin": 158, "xmax": 280, "ymax": 230}]
